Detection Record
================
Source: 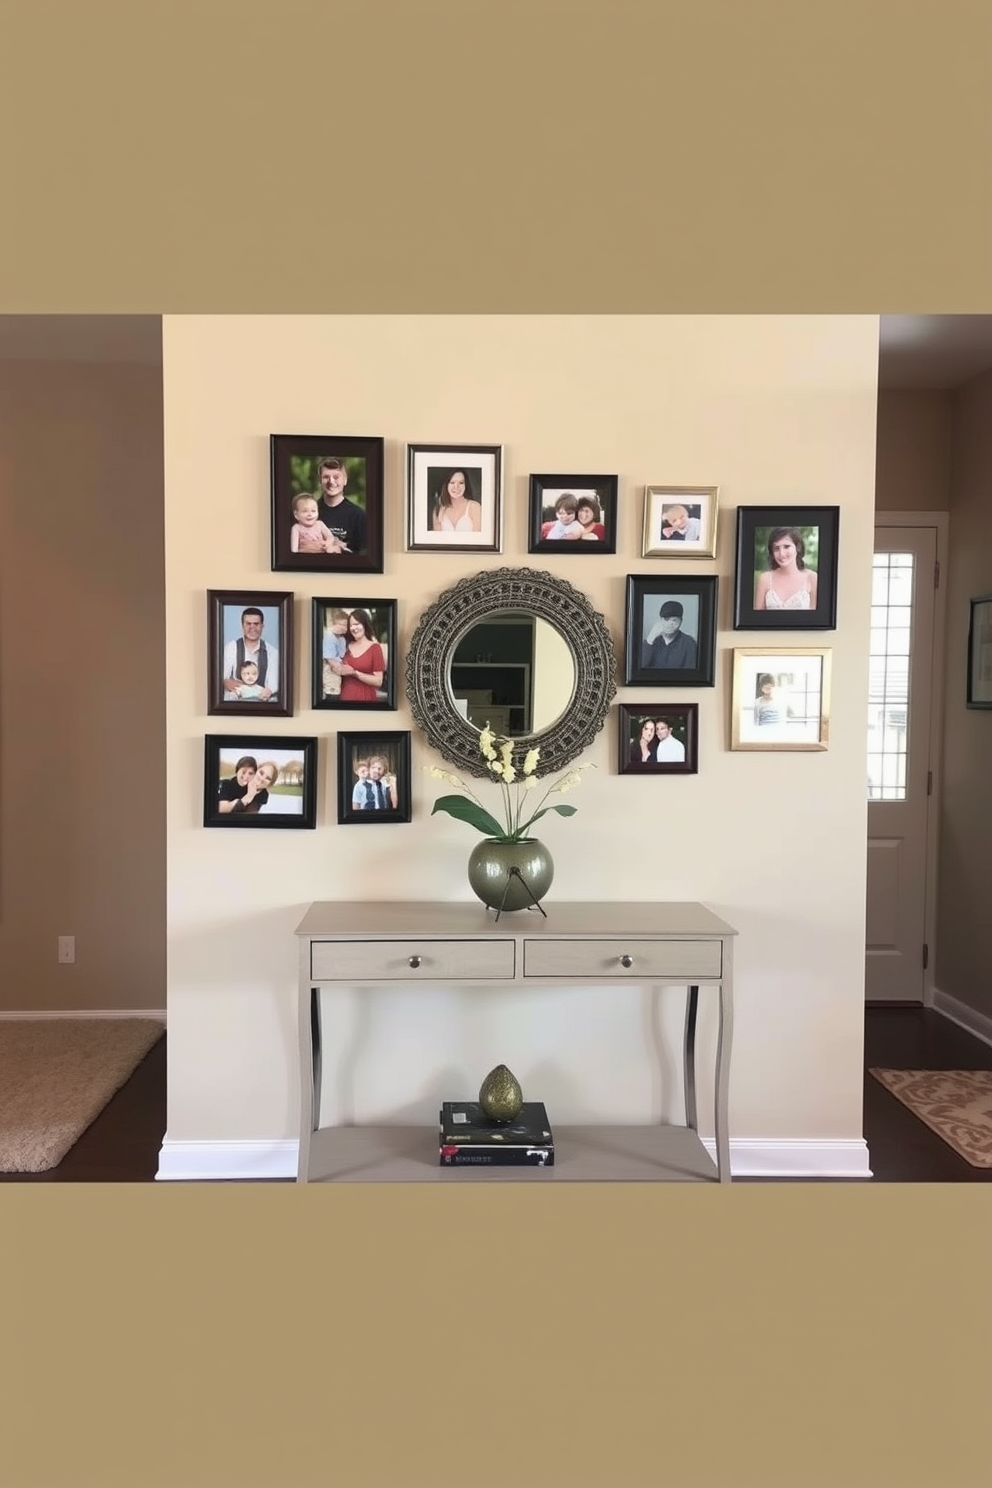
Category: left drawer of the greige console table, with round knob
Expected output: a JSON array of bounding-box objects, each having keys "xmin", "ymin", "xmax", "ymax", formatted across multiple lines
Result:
[{"xmin": 309, "ymin": 940, "xmax": 515, "ymax": 982}]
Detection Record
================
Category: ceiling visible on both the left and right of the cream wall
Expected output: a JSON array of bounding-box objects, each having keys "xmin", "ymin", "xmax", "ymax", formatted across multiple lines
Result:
[{"xmin": 0, "ymin": 315, "xmax": 992, "ymax": 388}]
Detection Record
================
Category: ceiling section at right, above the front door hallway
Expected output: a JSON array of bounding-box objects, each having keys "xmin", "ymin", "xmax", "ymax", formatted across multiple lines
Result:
[{"xmin": 879, "ymin": 315, "xmax": 992, "ymax": 388}]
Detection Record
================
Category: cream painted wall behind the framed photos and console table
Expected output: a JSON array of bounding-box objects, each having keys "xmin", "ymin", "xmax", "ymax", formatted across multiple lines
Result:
[{"xmin": 164, "ymin": 315, "xmax": 877, "ymax": 1141}]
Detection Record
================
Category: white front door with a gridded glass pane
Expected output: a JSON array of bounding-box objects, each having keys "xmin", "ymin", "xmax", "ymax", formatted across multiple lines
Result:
[{"xmin": 864, "ymin": 527, "xmax": 937, "ymax": 1003}]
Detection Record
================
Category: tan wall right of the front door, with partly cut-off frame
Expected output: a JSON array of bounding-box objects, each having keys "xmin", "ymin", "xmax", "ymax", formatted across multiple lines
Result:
[{"xmin": 935, "ymin": 372, "xmax": 992, "ymax": 1016}]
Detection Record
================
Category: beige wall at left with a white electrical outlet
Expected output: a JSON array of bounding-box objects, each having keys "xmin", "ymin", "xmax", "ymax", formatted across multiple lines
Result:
[{"xmin": 0, "ymin": 362, "xmax": 165, "ymax": 1012}]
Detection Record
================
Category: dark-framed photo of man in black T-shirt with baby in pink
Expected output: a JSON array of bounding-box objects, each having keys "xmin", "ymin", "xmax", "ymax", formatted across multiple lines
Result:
[{"xmin": 269, "ymin": 434, "xmax": 384, "ymax": 573}]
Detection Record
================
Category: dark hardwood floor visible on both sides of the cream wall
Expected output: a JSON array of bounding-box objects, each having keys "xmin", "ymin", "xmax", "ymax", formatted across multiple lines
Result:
[{"xmin": 0, "ymin": 1007, "xmax": 992, "ymax": 1183}]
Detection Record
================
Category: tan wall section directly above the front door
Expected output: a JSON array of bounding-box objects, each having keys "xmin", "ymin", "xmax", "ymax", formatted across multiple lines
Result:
[{"xmin": 875, "ymin": 388, "xmax": 952, "ymax": 512}]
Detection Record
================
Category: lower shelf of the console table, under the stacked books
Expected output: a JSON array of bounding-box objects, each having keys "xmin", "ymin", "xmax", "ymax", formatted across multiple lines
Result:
[{"xmin": 298, "ymin": 1126, "xmax": 718, "ymax": 1183}]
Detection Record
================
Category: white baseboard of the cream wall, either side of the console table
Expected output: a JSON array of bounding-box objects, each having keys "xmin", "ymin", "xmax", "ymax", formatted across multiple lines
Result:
[{"xmin": 156, "ymin": 1134, "xmax": 872, "ymax": 1183}]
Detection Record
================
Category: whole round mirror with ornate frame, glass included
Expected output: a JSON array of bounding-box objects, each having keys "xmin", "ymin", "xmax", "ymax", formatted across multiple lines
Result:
[{"xmin": 406, "ymin": 568, "xmax": 616, "ymax": 775}]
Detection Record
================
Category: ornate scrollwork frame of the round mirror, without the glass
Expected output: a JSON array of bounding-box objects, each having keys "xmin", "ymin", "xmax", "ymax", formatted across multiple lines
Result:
[{"xmin": 406, "ymin": 568, "xmax": 617, "ymax": 777}]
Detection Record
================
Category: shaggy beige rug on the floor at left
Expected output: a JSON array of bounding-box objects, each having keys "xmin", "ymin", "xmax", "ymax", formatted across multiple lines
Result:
[{"xmin": 0, "ymin": 1018, "xmax": 165, "ymax": 1173}]
